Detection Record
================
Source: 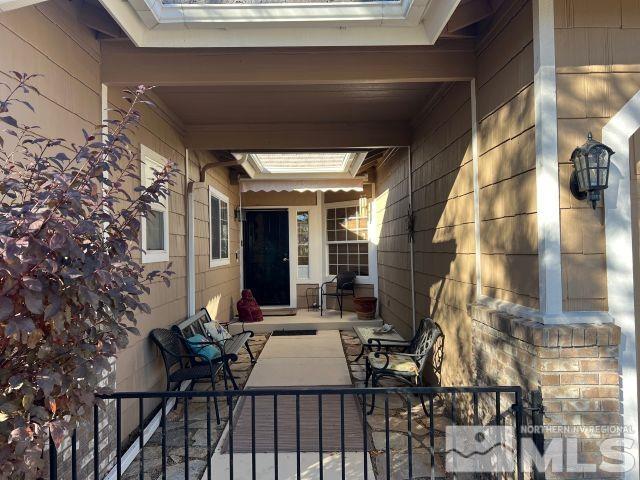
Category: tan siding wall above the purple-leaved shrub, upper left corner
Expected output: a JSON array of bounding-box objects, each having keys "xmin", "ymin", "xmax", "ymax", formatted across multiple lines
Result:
[{"xmin": 0, "ymin": 0, "xmax": 101, "ymax": 142}]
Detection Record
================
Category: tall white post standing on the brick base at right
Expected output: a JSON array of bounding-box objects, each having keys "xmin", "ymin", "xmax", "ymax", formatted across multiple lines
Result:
[{"xmin": 533, "ymin": 0, "xmax": 562, "ymax": 323}]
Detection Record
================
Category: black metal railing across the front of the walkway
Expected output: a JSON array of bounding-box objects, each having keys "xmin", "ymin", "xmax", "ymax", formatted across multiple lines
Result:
[{"xmin": 49, "ymin": 386, "xmax": 524, "ymax": 480}]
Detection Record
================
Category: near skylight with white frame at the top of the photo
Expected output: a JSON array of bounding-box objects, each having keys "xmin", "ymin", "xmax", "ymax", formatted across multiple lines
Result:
[{"xmin": 100, "ymin": 0, "xmax": 460, "ymax": 47}]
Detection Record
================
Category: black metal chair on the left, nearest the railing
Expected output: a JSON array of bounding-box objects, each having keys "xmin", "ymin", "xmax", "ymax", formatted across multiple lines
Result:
[{"xmin": 150, "ymin": 328, "xmax": 231, "ymax": 424}]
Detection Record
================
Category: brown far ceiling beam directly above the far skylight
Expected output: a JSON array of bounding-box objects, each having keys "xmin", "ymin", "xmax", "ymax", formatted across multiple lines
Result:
[{"xmin": 185, "ymin": 122, "xmax": 411, "ymax": 151}]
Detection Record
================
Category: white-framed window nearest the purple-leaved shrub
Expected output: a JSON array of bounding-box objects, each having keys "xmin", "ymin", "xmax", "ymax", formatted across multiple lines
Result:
[{"xmin": 140, "ymin": 145, "xmax": 169, "ymax": 263}]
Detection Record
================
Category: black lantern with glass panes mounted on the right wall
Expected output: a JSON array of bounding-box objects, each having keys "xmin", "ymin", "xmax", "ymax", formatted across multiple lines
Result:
[{"xmin": 570, "ymin": 132, "xmax": 615, "ymax": 209}]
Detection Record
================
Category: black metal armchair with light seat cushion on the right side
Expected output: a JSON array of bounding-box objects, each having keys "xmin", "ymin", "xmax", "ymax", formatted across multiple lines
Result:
[{"xmin": 364, "ymin": 318, "xmax": 442, "ymax": 414}]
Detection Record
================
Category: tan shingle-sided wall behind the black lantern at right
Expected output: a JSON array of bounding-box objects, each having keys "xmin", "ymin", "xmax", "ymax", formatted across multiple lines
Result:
[{"xmin": 554, "ymin": 0, "xmax": 640, "ymax": 310}]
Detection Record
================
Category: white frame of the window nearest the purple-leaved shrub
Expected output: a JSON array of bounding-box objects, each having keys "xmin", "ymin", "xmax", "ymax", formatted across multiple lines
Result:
[{"xmin": 140, "ymin": 145, "xmax": 169, "ymax": 263}]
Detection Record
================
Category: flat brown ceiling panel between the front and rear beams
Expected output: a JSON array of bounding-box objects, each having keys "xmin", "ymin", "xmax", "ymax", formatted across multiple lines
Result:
[{"xmin": 151, "ymin": 83, "xmax": 438, "ymax": 128}]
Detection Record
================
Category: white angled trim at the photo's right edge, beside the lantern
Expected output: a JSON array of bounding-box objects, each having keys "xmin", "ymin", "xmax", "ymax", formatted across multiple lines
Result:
[{"xmin": 602, "ymin": 92, "xmax": 640, "ymax": 479}]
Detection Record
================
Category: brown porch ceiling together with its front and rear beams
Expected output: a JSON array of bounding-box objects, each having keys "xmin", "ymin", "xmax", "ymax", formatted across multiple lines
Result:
[{"xmin": 102, "ymin": 40, "xmax": 475, "ymax": 151}]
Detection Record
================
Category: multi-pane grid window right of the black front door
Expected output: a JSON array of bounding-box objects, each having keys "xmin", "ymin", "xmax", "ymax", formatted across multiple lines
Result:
[{"xmin": 326, "ymin": 205, "xmax": 369, "ymax": 277}]
